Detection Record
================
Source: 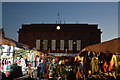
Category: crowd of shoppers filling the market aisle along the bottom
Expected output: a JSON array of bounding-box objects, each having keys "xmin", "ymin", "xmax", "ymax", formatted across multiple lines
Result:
[{"xmin": 0, "ymin": 52, "xmax": 120, "ymax": 80}]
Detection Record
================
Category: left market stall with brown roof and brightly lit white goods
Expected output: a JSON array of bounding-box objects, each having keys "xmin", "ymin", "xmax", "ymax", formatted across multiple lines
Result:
[{"xmin": 0, "ymin": 34, "xmax": 37, "ymax": 79}]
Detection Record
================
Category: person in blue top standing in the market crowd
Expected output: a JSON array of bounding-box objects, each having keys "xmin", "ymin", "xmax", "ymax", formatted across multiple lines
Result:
[{"xmin": 38, "ymin": 59, "xmax": 46, "ymax": 79}]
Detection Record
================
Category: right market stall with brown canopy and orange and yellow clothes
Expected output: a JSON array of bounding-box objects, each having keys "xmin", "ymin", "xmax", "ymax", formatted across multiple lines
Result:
[{"xmin": 80, "ymin": 38, "xmax": 120, "ymax": 78}]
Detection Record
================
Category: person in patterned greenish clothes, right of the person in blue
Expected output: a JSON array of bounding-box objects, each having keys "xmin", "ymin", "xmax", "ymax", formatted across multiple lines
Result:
[{"xmin": 49, "ymin": 59, "xmax": 58, "ymax": 80}]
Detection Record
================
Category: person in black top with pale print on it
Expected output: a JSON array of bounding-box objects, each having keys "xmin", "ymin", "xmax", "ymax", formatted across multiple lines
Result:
[{"xmin": 65, "ymin": 57, "xmax": 76, "ymax": 80}]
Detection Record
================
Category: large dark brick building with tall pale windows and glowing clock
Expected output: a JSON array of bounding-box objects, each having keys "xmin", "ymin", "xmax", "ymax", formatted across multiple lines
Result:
[{"xmin": 18, "ymin": 24, "xmax": 101, "ymax": 53}]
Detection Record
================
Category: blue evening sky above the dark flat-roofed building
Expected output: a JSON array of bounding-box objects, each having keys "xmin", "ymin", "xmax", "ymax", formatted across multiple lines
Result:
[{"xmin": 2, "ymin": 2, "xmax": 118, "ymax": 42}]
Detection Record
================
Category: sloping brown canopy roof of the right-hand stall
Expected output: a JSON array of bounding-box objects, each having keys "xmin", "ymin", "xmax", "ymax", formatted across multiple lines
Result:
[{"xmin": 81, "ymin": 37, "xmax": 120, "ymax": 54}]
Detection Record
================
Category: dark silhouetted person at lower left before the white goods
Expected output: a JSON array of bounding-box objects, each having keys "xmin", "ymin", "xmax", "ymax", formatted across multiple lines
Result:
[{"xmin": 8, "ymin": 63, "xmax": 22, "ymax": 80}]
